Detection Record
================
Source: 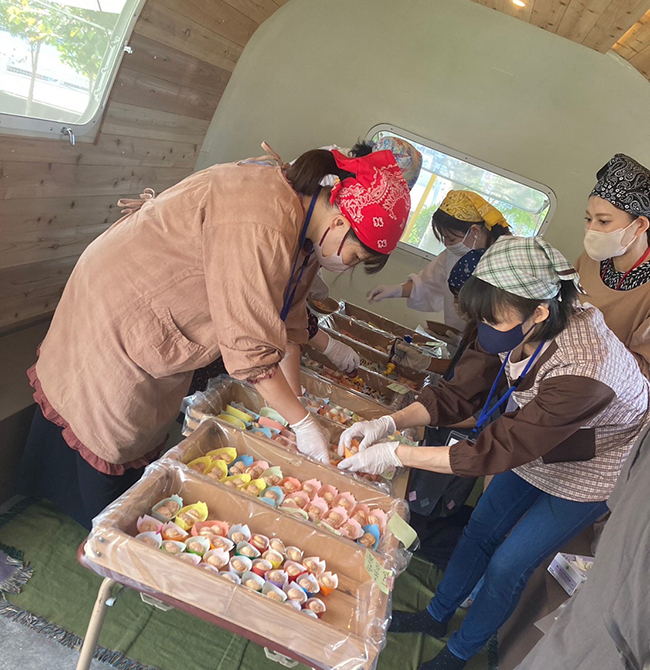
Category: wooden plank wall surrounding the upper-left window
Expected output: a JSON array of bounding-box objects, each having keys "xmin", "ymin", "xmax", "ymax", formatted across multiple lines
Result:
[{"xmin": 0, "ymin": 0, "xmax": 284, "ymax": 331}]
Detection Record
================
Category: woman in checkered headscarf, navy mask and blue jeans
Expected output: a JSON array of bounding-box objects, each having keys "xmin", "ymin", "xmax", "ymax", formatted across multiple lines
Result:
[{"xmin": 339, "ymin": 237, "xmax": 650, "ymax": 670}]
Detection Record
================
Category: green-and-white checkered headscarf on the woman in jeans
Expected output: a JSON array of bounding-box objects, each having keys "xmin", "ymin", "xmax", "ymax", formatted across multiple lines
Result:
[{"xmin": 474, "ymin": 236, "xmax": 582, "ymax": 300}]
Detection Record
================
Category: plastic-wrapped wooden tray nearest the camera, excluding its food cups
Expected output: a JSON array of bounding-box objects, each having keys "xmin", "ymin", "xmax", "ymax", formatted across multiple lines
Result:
[{"xmin": 84, "ymin": 459, "xmax": 400, "ymax": 670}]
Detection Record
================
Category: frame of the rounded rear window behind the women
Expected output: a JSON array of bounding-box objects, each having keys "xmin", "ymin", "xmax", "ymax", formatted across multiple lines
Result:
[{"xmin": 366, "ymin": 123, "xmax": 557, "ymax": 261}]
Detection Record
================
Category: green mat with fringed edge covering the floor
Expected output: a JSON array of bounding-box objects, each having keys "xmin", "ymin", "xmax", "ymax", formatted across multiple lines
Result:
[{"xmin": 0, "ymin": 503, "xmax": 496, "ymax": 670}]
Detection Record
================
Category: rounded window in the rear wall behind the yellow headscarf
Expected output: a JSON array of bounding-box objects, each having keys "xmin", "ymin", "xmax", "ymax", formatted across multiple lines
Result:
[{"xmin": 368, "ymin": 125, "xmax": 555, "ymax": 258}]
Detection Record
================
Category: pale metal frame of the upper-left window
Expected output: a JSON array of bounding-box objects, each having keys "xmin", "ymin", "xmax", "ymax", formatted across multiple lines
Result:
[{"xmin": 0, "ymin": 0, "xmax": 146, "ymax": 143}]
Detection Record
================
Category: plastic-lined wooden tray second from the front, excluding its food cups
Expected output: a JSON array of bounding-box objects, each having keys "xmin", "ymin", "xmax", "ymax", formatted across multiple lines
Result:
[{"xmin": 165, "ymin": 419, "xmax": 411, "ymax": 574}]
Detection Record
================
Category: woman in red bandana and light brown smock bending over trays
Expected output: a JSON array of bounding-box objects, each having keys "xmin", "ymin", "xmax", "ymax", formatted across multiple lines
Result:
[{"xmin": 21, "ymin": 150, "xmax": 410, "ymax": 526}]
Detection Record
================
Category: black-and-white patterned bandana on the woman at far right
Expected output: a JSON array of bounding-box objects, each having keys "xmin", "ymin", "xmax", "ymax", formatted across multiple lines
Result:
[{"xmin": 591, "ymin": 154, "xmax": 650, "ymax": 218}]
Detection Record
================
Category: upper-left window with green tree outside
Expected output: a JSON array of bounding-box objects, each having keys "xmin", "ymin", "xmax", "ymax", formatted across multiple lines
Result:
[{"xmin": 0, "ymin": 0, "xmax": 141, "ymax": 133}]
